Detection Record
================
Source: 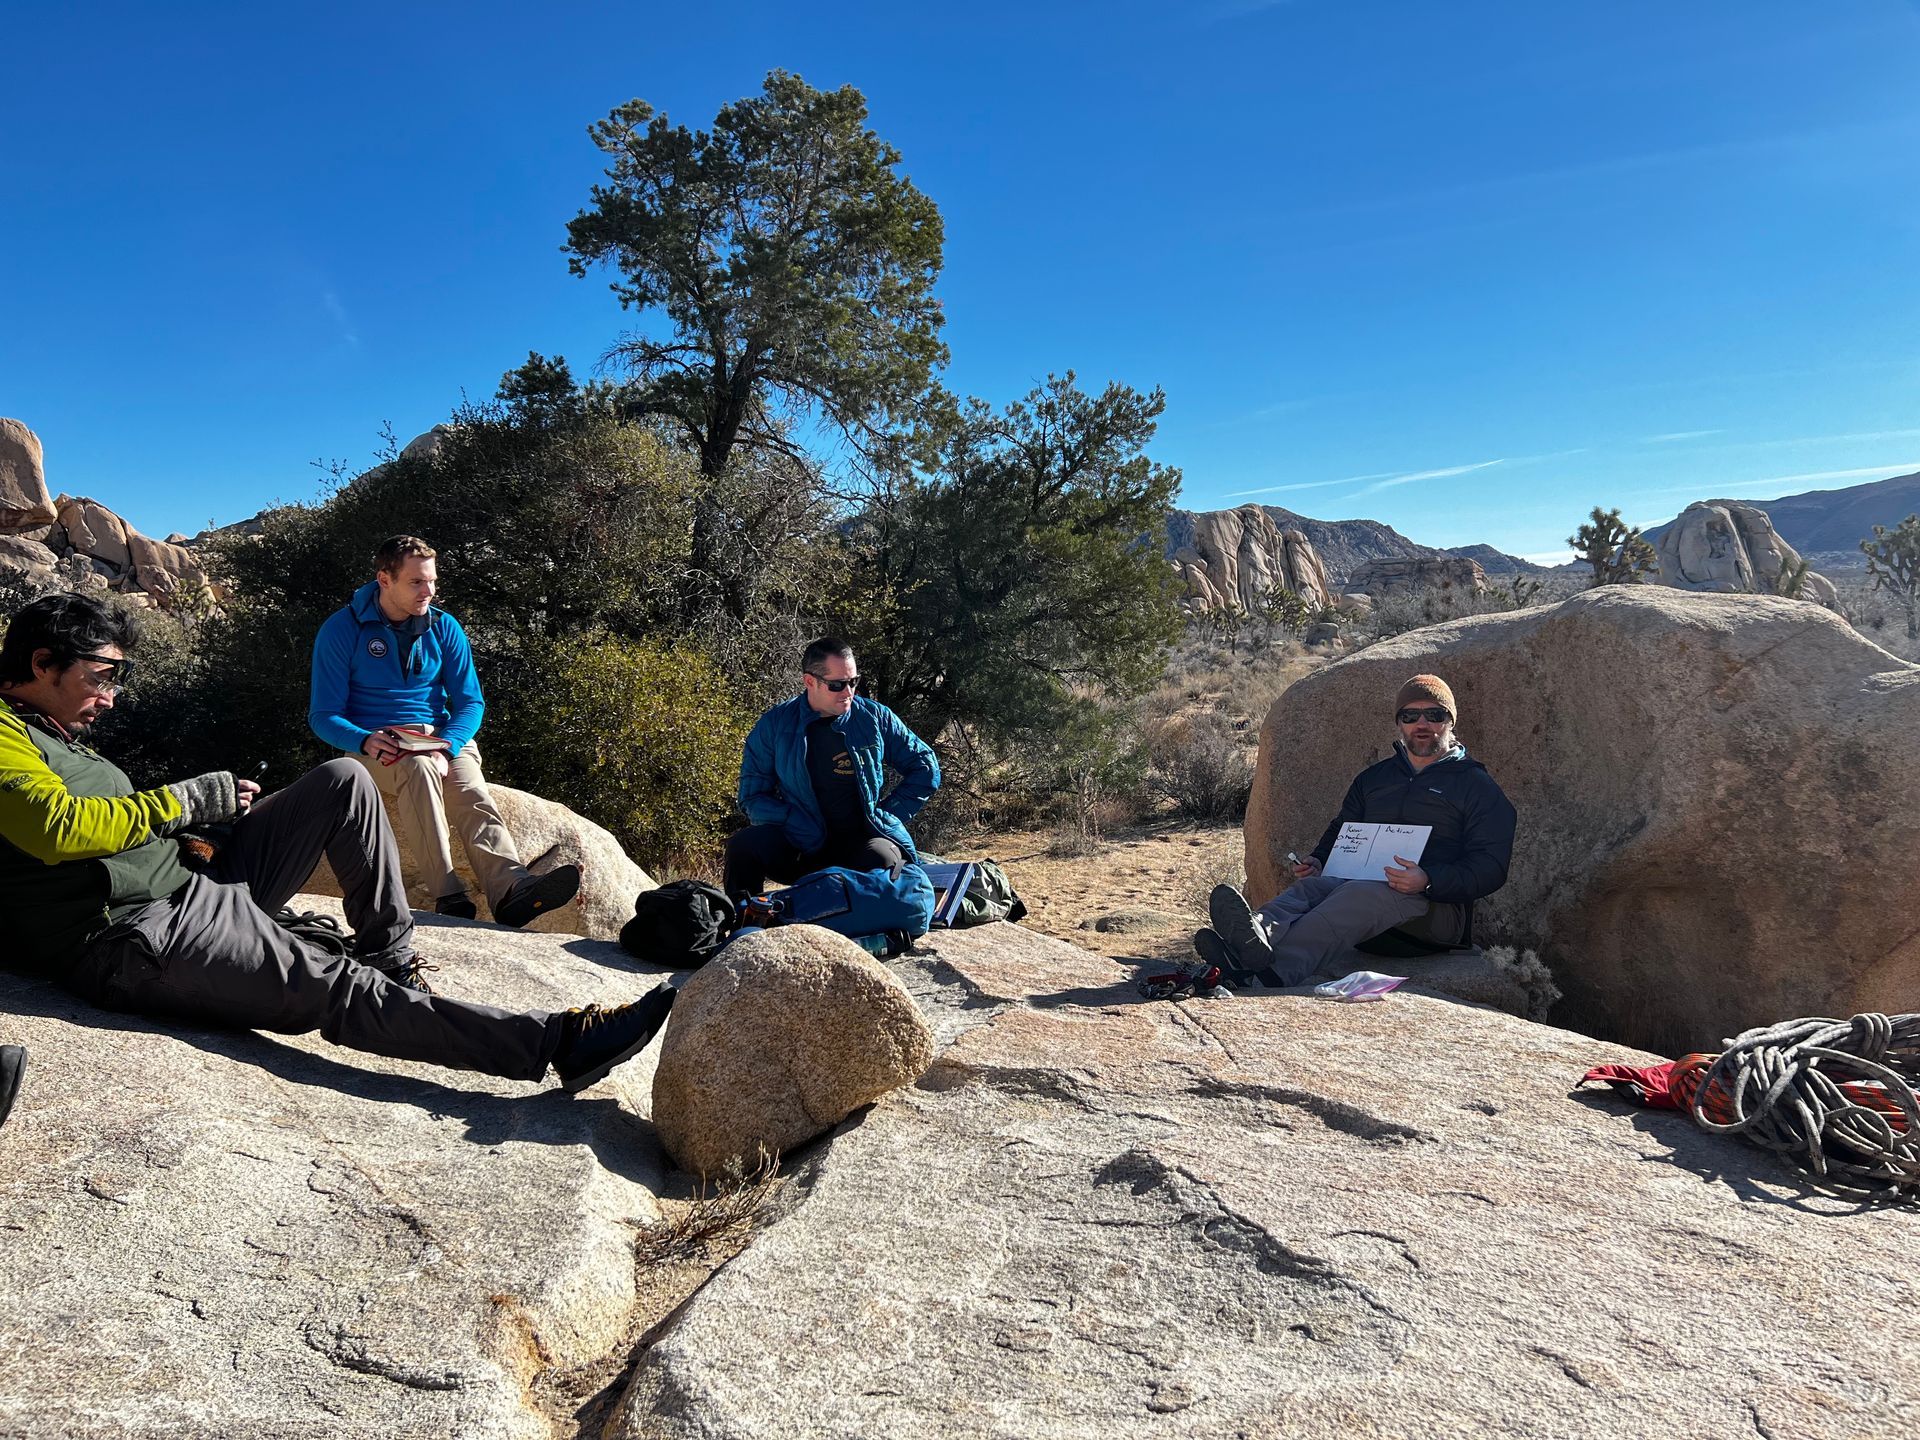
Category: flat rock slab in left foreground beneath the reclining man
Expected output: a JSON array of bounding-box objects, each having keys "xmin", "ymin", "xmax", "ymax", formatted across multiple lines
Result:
[{"xmin": 0, "ymin": 913, "xmax": 666, "ymax": 1440}]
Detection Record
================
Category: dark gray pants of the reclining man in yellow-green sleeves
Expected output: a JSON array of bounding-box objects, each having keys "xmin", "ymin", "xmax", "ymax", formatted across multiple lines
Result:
[{"xmin": 65, "ymin": 758, "xmax": 561, "ymax": 1079}]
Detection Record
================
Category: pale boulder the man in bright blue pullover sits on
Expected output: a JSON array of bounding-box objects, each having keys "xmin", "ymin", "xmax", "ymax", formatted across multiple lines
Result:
[{"xmin": 309, "ymin": 781, "xmax": 653, "ymax": 941}]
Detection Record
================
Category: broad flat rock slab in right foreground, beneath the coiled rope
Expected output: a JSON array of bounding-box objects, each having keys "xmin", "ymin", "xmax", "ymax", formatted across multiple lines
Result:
[{"xmin": 607, "ymin": 925, "xmax": 1920, "ymax": 1440}]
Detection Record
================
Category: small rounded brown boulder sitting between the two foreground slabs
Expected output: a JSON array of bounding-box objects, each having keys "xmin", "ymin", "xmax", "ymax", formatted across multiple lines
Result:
[{"xmin": 653, "ymin": 925, "xmax": 933, "ymax": 1177}]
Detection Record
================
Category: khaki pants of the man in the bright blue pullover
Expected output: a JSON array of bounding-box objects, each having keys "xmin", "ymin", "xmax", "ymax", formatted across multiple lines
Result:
[{"xmin": 359, "ymin": 741, "xmax": 526, "ymax": 908}]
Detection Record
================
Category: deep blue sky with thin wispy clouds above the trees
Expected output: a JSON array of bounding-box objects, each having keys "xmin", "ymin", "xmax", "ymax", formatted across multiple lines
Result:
[{"xmin": 0, "ymin": 0, "xmax": 1920, "ymax": 555}]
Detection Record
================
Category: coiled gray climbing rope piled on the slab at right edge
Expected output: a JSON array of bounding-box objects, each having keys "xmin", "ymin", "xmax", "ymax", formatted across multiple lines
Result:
[{"xmin": 1674, "ymin": 1014, "xmax": 1920, "ymax": 1200}]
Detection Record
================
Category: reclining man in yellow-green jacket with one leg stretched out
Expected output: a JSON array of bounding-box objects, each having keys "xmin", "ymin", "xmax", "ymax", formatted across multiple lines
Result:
[{"xmin": 0, "ymin": 595, "xmax": 674, "ymax": 1091}]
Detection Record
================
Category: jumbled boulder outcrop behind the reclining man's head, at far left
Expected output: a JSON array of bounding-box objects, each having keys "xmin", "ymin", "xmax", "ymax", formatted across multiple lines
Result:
[{"xmin": 0, "ymin": 419, "xmax": 225, "ymax": 609}]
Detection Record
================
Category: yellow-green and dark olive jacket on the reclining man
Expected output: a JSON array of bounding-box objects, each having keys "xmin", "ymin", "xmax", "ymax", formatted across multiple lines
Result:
[{"xmin": 0, "ymin": 701, "xmax": 192, "ymax": 973}]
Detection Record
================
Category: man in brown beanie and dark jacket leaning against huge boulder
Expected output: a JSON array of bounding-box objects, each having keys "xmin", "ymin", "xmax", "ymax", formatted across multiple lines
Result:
[{"xmin": 1194, "ymin": 676, "xmax": 1513, "ymax": 985}]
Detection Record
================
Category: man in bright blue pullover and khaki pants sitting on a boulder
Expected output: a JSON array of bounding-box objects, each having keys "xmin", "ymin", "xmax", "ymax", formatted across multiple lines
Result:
[{"xmin": 307, "ymin": 536, "xmax": 580, "ymax": 925}]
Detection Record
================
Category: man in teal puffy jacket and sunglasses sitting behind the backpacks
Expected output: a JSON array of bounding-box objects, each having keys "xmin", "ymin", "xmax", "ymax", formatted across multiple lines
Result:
[{"xmin": 724, "ymin": 636, "xmax": 941, "ymax": 897}]
